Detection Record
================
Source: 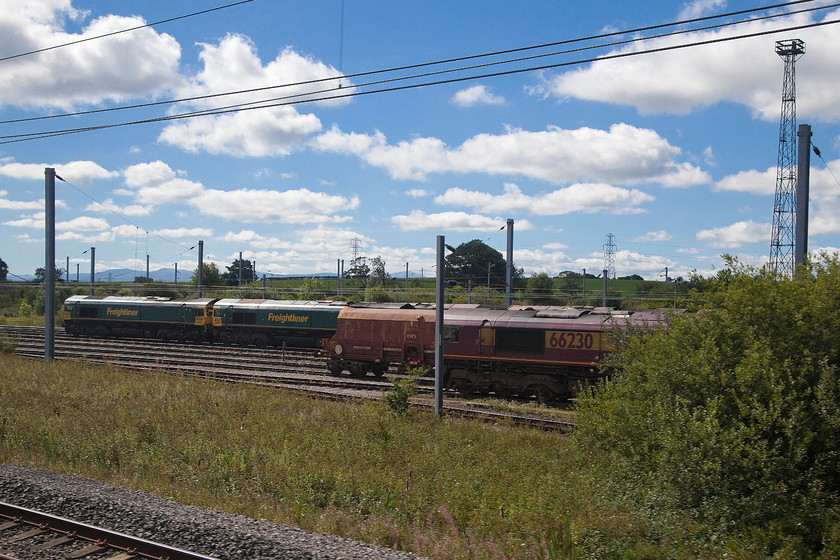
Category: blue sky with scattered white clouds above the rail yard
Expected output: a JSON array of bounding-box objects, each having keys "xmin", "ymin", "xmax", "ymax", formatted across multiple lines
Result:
[{"xmin": 0, "ymin": 0, "xmax": 840, "ymax": 281}]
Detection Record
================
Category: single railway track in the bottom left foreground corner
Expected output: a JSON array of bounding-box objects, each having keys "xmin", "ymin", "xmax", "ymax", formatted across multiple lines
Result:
[{"xmin": 0, "ymin": 502, "xmax": 220, "ymax": 560}]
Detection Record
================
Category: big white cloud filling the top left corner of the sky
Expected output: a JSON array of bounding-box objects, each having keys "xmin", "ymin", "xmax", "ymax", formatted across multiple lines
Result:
[{"xmin": 0, "ymin": 0, "xmax": 181, "ymax": 109}]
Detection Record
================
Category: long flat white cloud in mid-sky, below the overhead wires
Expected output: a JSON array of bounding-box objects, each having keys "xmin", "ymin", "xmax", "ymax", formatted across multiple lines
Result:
[{"xmin": 313, "ymin": 124, "xmax": 709, "ymax": 187}]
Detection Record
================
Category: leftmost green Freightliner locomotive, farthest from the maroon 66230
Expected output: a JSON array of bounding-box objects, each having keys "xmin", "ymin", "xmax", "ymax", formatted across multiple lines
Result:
[{"xmin": 64, "ymin": 296, "xmax": 216, "ymax": 342}]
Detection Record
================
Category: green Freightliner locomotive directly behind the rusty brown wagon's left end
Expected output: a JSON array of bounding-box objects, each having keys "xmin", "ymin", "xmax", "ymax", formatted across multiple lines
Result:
[{"xmin": 213, "ymin": 299, "xmax": 346, "ymax": 348}]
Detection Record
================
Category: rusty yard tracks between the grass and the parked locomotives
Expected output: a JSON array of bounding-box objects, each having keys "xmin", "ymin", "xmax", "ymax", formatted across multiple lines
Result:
[{"xmin": 0, "ymin": 326, "xmax": 574, "ymax": 431}]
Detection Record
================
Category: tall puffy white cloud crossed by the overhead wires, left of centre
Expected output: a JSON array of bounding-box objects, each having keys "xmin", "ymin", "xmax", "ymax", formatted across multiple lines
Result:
[{"xmin": 158, "ymin": 34, "xmax": 353, "ymax": 157}]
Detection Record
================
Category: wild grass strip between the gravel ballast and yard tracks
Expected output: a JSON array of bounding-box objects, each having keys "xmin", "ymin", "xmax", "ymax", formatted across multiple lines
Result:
[{"xmin": 0, "ymin": 354, "xmax": 716, "ymax": 560}]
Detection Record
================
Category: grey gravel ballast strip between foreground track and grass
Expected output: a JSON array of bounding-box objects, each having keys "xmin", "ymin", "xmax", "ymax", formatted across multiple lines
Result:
[{"xmin": 0, "ymin": 463, "xmax": 420, "ymax": 560}]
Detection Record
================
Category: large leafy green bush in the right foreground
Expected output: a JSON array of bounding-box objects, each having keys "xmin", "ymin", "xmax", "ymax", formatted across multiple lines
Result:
[{"xmin": 574, "ymin": 255, "xmax": 840, "ymax": 557}]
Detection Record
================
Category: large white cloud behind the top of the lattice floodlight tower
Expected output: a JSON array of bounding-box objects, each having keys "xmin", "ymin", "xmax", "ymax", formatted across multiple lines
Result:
[{"xmin": 533, "ymin": 6, "xmax": 840, "ymax": 121}]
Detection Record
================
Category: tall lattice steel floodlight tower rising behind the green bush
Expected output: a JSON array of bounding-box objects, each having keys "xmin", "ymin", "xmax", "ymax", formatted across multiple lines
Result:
[{"xmin": 770, "ymin": 39, "xmax": 805, "ymax": 278}]
